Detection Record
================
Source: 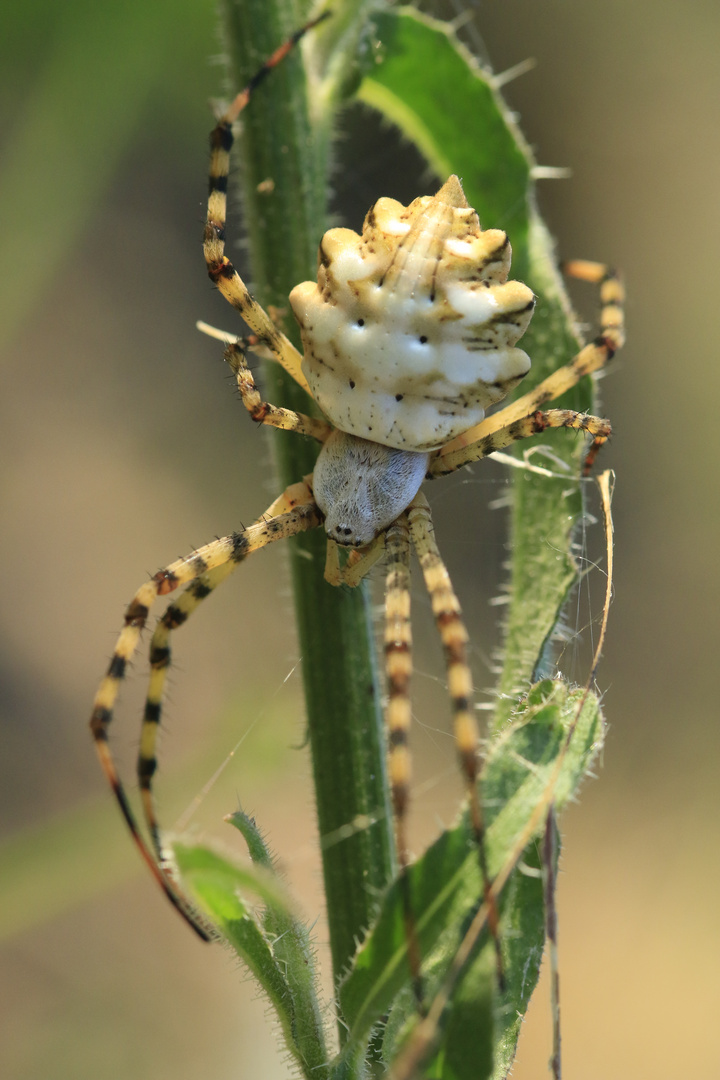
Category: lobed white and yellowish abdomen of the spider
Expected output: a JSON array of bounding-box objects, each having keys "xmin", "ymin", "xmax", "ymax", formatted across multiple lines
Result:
[{"xmin": 290, "ymin": 176, "xmax": 534, "ymax": 451}]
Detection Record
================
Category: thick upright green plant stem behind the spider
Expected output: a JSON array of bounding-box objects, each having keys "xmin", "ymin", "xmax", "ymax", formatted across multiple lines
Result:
[{"xmin": 225, "ymin": 0, "xmax": 393, "ymax": 993}]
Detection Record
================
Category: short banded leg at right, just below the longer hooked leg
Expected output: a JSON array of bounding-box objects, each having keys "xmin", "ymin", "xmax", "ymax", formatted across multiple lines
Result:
[{"xmin": 427, "ymin": 408, "xmax": 611, "ymax": 480}]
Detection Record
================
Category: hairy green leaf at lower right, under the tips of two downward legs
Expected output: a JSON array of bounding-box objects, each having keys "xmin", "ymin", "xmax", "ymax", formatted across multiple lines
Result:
[{"xmin": 340, "ymin": 680, "xmax": 602, "ymax": 1080}]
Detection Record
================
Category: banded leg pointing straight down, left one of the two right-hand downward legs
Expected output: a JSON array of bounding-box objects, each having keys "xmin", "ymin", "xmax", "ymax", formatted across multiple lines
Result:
[{"xmin": 384, "ymin": 514, "xmax": 424, "ymax": 1012}]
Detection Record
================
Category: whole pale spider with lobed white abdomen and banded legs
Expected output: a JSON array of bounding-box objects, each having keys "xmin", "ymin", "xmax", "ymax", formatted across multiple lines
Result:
[{"xmin": 91, "ymin": 12, "xmax": 623, "ymax": 1000}]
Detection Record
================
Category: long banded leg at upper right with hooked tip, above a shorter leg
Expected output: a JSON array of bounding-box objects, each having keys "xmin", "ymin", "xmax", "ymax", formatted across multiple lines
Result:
[{"xmin": 433, "ymin": 260, "xmax": 625, "ymax": 464}]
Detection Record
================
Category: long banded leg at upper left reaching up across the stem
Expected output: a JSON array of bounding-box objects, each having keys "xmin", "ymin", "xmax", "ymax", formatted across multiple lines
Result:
[{"xmin": 203, "ymin": 12, "xmax": 329, "ymax": 390}]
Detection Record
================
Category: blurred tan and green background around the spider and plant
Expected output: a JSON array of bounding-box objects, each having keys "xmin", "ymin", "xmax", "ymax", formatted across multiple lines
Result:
[{"xmin": 0, "ymin": 0, "xmax": 720, "ymax": 1080}]
